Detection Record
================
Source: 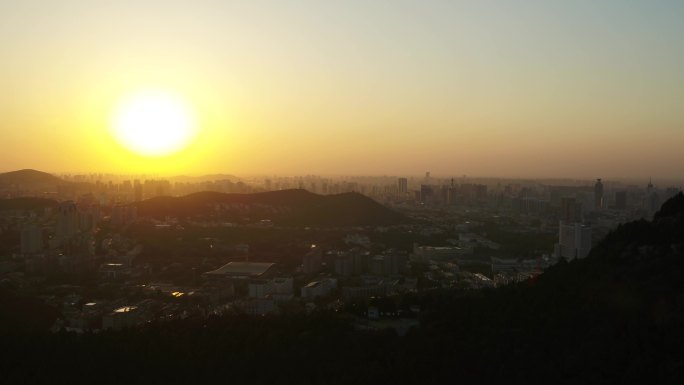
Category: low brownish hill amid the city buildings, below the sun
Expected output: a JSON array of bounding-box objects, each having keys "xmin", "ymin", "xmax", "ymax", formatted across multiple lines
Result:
[{"xmin": 135, "ymin": 190, "xmax": 405, "ymax": 226}]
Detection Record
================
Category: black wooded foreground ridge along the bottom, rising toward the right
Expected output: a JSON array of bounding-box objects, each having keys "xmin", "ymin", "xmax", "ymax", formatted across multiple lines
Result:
[{"xmin": 0, "ymin": 193, "xmax": 684, "ymax": 384}]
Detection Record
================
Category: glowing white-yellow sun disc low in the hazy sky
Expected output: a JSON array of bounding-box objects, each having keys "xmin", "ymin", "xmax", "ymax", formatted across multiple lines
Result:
[{"xmin": 110, "ymin": 90, "xmax": 198, "ymax": 157}]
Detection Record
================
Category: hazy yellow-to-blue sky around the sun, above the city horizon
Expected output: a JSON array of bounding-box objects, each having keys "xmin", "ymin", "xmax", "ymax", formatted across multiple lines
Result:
[{"xmin": 0, "ymin": 0, "xmax": 684, "ymax": 177}]
